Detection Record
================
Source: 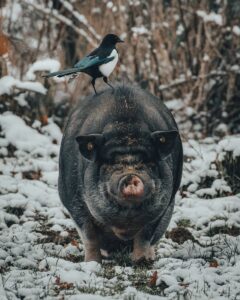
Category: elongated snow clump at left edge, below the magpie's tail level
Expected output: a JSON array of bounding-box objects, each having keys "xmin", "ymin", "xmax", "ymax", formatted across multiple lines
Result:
[{"xmin": 0, "ymin": 76, "xmax": 47, "ymax": 95}]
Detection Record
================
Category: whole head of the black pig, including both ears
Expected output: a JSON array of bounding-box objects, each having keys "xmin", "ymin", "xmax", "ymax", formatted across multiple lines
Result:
[{"xmin": 77, "ymin": 130, "xmax": 178, "ymax": 226}]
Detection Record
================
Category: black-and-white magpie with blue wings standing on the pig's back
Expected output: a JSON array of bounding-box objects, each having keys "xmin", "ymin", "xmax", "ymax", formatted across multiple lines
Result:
[{"xmin": 44, "ymin": 34, "xmax": 123, "ymax": 94}]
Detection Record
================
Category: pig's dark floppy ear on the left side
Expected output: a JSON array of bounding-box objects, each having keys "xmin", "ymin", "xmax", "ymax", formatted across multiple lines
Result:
[{"xmin": 76, "ymin": 134, "xmax": 103, "ymax": 160}]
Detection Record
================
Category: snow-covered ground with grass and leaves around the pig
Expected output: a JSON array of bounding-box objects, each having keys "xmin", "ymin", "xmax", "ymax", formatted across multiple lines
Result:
[{"xmin": 0, "ymin": 113, "xmax": 240, "ymax": 300}]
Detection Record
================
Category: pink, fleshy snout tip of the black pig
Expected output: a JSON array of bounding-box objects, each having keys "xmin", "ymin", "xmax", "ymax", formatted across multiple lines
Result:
[{"xmin": 118, "ymin": 174, "xmax": 144, "ymax": 198}]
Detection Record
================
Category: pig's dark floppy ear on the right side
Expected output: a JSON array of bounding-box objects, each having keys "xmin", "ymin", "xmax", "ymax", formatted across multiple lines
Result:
[{"xmin": 151, "ymin": 130, "xmax": 179, "ymax": 160}]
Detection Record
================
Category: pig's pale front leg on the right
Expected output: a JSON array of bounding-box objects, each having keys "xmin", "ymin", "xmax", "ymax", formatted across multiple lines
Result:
[{"xmin": 132, "ymin": 231, "xmax": 155, "ymax": 263}]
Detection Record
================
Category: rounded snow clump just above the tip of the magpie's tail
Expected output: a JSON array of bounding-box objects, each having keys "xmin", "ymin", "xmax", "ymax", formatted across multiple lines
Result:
[{"xmin": 26, "ymin": 58, "xmax": 60, "ymax": 80}]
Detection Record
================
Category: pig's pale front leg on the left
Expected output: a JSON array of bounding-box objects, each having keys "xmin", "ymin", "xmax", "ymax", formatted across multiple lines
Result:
[{"xmin": 78, "ymin": 220, "xmax": 102, "ymax": 263}]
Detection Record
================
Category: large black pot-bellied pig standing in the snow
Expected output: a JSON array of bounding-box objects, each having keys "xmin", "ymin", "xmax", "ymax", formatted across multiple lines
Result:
[{"xmin": 59, "ymin": 86, "xmax": 182, "ymax": 261}]
